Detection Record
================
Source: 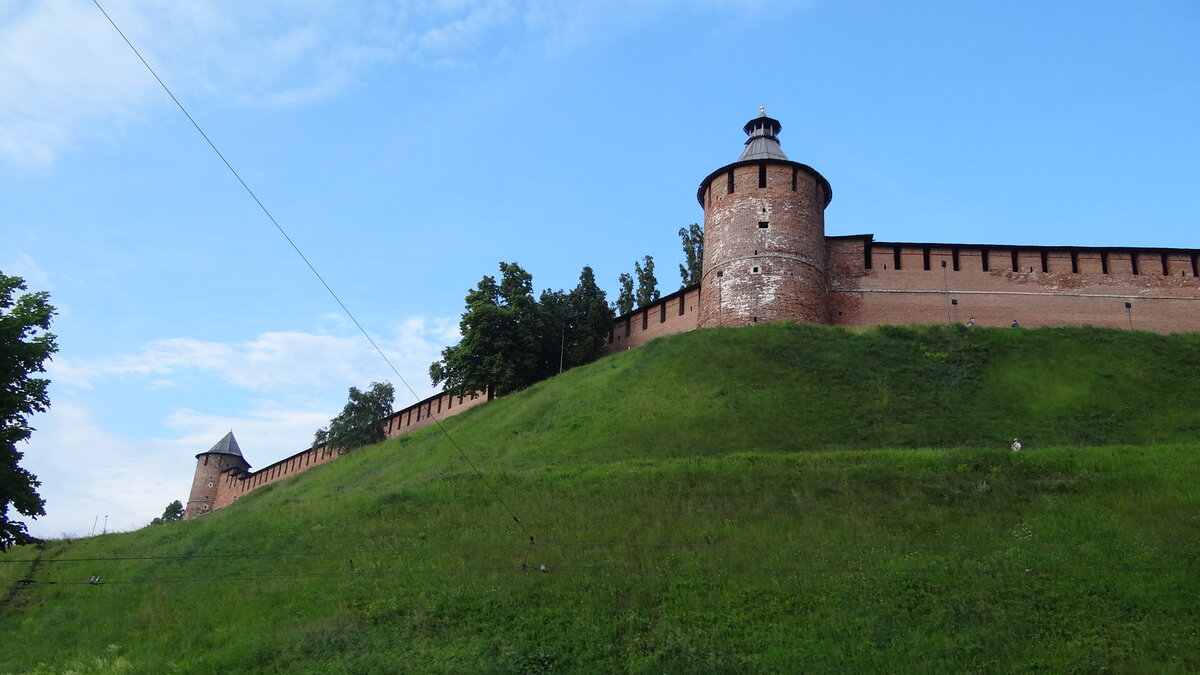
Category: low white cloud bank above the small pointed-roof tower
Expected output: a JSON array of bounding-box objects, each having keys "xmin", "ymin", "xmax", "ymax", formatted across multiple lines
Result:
[{"xmin": 20, "ymin": 317, "xmax": 458, "ymax": 537}]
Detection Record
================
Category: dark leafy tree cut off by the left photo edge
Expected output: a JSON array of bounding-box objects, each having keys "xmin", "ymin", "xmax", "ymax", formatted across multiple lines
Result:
[{"xmin": 0, "ymin": 273, "xmax": 58, "ymax": 551}]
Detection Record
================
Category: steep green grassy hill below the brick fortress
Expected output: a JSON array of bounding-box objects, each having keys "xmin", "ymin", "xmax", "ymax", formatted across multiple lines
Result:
[{"xmin": 0, "ymin": 324, "xmax": 1200, "ymax": 673}]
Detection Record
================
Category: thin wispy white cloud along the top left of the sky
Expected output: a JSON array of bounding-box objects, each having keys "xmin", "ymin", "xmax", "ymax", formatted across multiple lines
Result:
[{"xmin": 0, "ymin": 0, "xmax": 787, "ymax": 167}]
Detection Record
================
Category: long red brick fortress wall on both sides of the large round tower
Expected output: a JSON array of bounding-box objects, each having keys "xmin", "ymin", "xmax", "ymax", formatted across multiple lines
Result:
[{"xmin": 199, "ymin": 234, "xmax": 1200, "ymax": 518}]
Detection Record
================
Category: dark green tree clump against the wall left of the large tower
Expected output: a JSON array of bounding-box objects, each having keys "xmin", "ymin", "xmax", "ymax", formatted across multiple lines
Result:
[{"xmin": 430, "ymin": 262, "xmax": 613, "ymax": 399}]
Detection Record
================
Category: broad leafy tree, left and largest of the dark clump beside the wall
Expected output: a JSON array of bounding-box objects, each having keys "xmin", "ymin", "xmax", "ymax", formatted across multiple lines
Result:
[{"xmin": 430, "ymin": 262, "xmax": 546, "ymax": 399}]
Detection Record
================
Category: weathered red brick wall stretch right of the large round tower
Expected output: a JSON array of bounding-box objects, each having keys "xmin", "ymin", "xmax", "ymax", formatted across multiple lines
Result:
[{"xmin": 828, "ymin": 237, "xmax": 1200, "ymax": 333}]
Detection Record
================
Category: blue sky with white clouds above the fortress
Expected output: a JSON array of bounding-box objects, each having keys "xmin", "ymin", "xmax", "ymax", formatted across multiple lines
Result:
[{"xmin": 0, "ymin": 0, "xmax": 1200, "ymax": 536}]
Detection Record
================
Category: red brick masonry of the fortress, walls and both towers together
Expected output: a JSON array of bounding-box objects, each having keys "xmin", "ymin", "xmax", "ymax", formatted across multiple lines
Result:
[{"xmin": 185, "ymin": 114, "xmax": 1200, "ymax": 518}]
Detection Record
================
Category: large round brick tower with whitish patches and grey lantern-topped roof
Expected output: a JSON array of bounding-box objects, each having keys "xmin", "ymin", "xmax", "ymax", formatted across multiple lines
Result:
[{"xmin": 696, "ymin": 108, "xmax": 833, "ymax": 328}]
